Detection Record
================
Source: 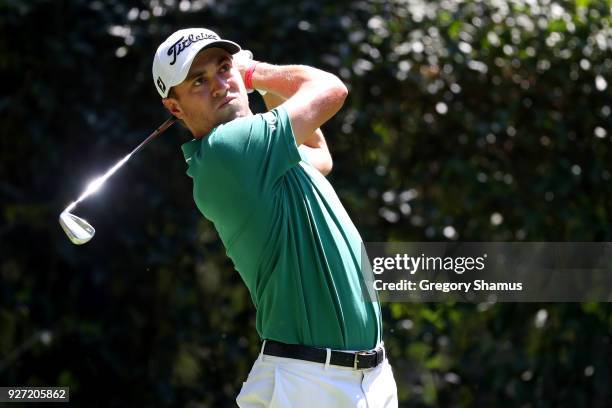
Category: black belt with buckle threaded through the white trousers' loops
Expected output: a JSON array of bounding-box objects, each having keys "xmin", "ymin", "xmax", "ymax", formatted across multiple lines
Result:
[{"xmin": 263, "ymin": 340, "xmax": 385, "ymax": 370}]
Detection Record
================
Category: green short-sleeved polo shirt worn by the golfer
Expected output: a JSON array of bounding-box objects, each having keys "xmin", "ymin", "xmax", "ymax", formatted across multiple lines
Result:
[{"xmin": 182, "ymin": 107, "xmax": 381, "ymax": 350}]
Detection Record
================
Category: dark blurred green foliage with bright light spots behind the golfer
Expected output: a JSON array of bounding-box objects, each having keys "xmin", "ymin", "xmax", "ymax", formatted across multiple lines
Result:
[{"xmin": 0, "ymin": 0, "xmax": 612, "ymax": 408}]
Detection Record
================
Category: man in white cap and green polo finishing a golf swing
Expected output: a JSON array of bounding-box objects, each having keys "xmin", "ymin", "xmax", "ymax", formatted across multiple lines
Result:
[{"xmin": 153, "ymin": 28, "xmax": 397, "ymax": 408}]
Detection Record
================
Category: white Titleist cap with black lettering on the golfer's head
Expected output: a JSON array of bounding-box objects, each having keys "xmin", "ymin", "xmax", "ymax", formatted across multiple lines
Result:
[{"xmin": 153, "ymin": 28, "xmax": 240, "ymax": 98}]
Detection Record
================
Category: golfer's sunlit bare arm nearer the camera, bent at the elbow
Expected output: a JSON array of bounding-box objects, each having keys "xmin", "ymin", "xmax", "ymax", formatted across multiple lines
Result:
[{"xmin": 246, "ymin": 62, "xmax": 348, "ymax": 145}]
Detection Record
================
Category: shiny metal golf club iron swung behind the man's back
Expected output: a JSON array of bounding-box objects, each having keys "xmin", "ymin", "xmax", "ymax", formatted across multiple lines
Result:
[{"xmin": 59, "ymin": 117, "xmax": 176, "ymax": 245}]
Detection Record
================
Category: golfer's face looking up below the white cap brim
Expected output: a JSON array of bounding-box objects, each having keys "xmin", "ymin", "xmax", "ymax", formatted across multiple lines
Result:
[{"xmin": 162, "ymin": 48, "xmax": 251, "ymax": 138}]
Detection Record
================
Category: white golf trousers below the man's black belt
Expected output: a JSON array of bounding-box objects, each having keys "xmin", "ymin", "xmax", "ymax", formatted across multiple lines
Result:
[{"xmin": 236, "ymin": 342, "xmax": 397, "ymax": 408}]
